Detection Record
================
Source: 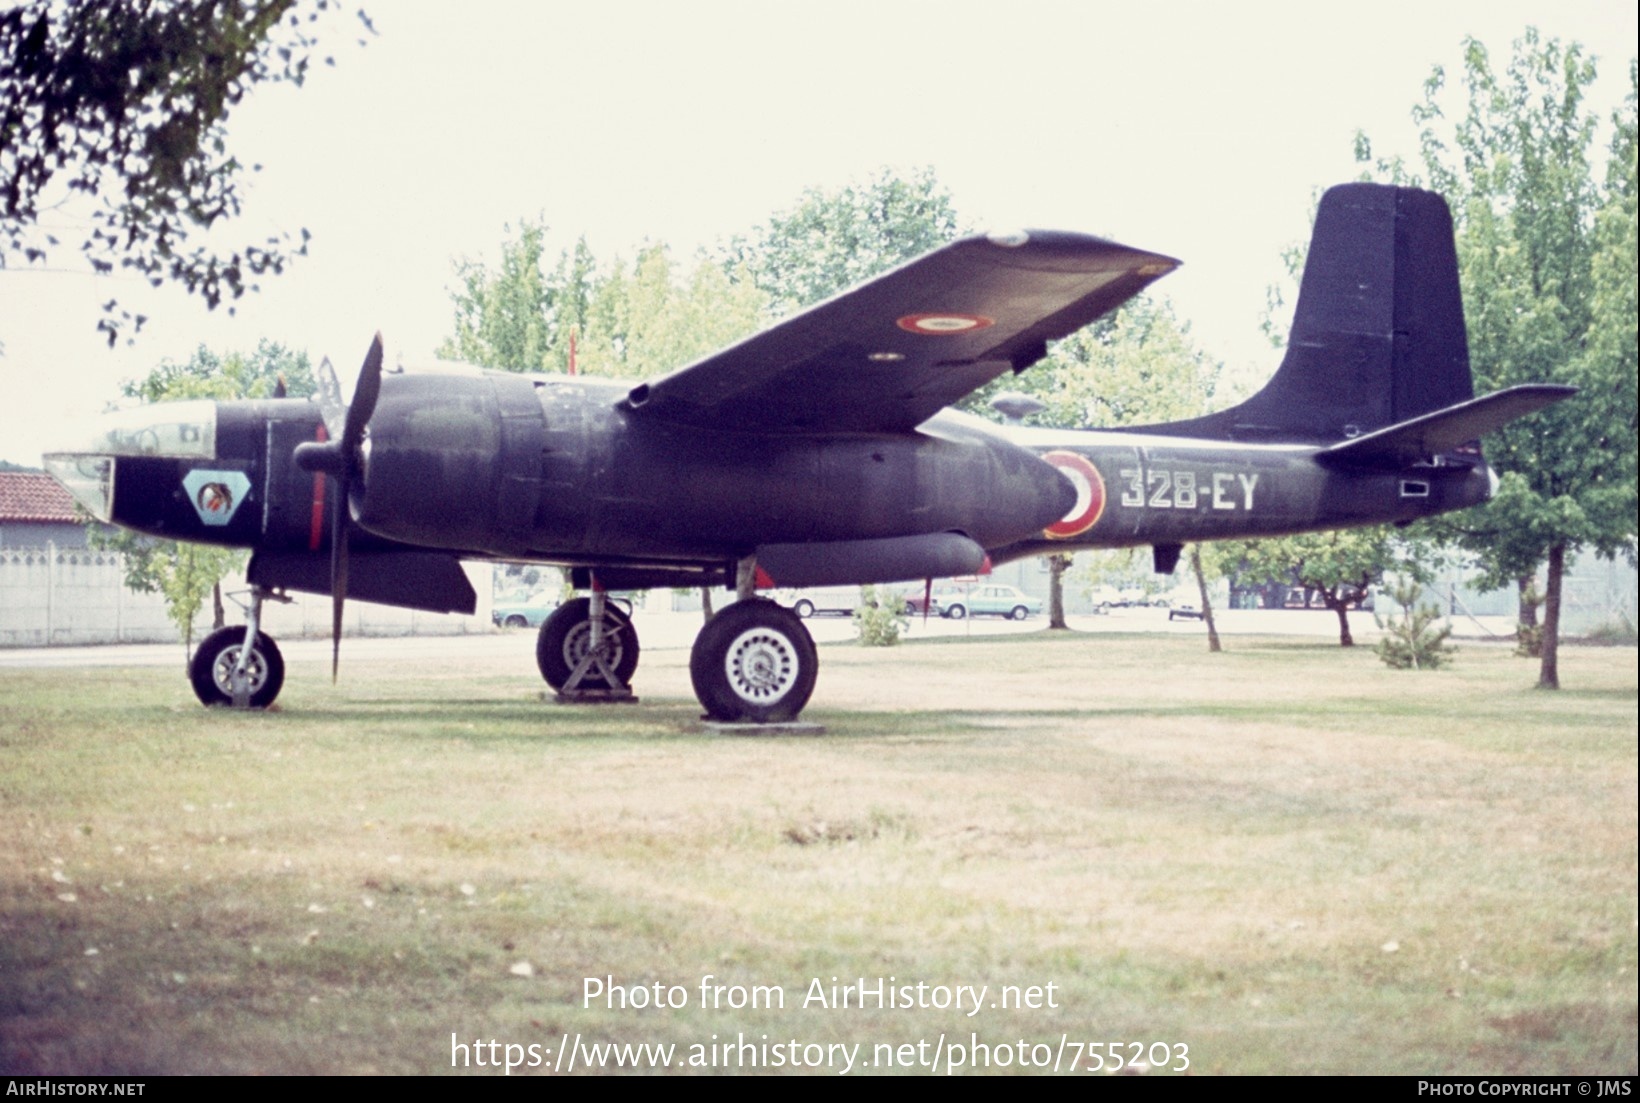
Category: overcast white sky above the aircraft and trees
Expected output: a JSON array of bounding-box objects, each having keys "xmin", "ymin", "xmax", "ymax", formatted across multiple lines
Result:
[{"xmin": 0, "ymin": 0, "xmax": 1637, "ymax": 464}]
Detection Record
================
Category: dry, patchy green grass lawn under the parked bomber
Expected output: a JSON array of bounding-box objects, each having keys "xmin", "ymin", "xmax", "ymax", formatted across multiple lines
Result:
[{"xmin": 0, "ymin": 634, "xmax": 1637, "ymax": 1073}]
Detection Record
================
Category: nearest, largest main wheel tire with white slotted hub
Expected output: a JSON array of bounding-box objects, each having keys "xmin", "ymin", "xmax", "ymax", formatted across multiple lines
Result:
[{"xmin": 689, "ymin": 598, "xmax": 820, "ymax": 724}]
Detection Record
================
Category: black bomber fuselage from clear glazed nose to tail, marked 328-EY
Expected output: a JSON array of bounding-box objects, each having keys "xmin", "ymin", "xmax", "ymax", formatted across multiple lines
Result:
[{"xmin": 41, "ymin": 372, "xmax": 1487, "ymax": 580}]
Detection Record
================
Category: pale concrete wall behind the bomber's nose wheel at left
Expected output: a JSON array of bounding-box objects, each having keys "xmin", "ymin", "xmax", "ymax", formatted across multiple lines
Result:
[{"xmin": 0, "ymin": 544, "xmax": 494, "ymax": 647}]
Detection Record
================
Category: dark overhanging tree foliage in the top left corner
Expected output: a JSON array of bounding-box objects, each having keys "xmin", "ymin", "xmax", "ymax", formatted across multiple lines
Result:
[{"xmin": 0, "ymin": 0, "xmax": 369, "ymax": 346}]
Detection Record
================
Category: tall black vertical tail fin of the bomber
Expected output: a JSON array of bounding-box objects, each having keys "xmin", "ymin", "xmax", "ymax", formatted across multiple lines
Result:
[{"xmin": 1146, "ymin": 184, "xmax": 1474, "ymax": 444}]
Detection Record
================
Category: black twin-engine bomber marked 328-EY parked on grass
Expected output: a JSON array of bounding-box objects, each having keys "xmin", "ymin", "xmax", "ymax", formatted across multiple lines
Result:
[{"xmin": 46, "ymin": 184, "xmax": 1571, "ymax": 723}]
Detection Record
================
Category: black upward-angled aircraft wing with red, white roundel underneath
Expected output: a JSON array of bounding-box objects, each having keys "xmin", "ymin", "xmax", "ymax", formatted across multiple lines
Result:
[{"xmin": 625, "ymin": 231, "xmax": 1179, "ymax": 433}]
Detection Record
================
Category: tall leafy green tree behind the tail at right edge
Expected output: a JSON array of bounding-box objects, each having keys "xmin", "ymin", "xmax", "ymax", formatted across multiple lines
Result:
[{"xmin": 1356, "ymin": 30, "xmax": 1637, "ymax": 688}]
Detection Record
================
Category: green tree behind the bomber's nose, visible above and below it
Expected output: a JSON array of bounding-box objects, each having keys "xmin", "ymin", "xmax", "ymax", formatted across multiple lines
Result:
[{"xmin": 89, "ymin": 339, "xmax": 315, "ymax": 651}]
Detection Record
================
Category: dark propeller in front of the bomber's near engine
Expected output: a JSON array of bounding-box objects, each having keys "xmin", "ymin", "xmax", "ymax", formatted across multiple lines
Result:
[{"xmin": 295, "ymin": 333, "xmax": 382, "ymax": 682}]
